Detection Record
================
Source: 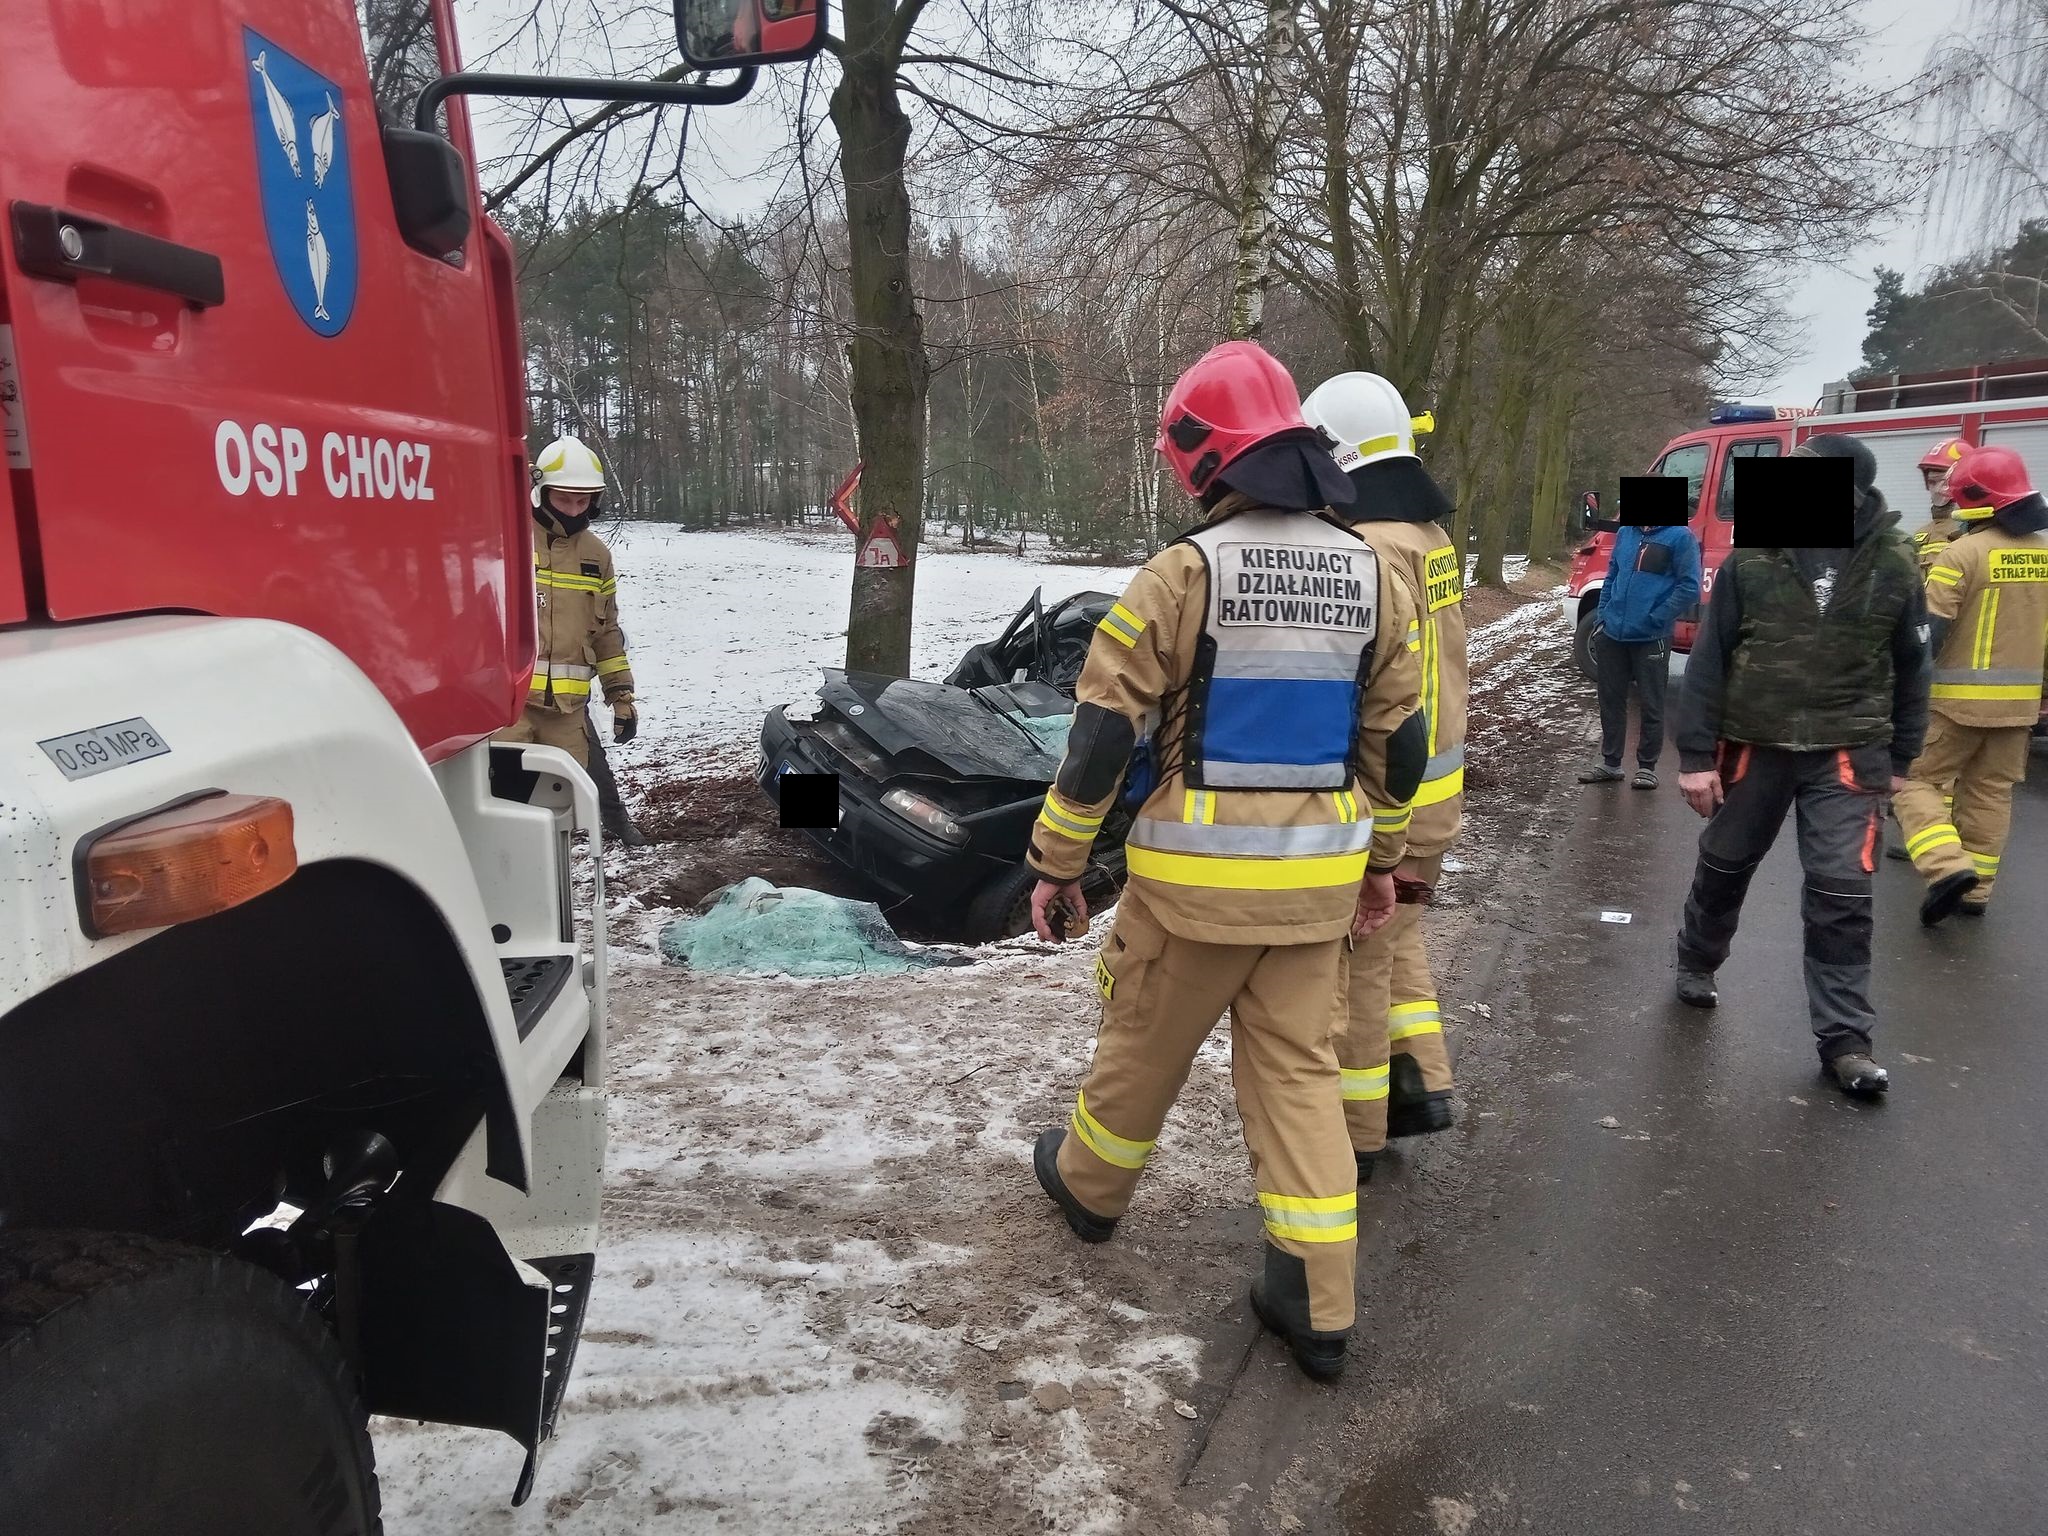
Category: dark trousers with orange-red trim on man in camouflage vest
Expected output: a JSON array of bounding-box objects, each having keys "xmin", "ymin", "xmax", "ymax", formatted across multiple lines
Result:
[{"xmin": 1677, "ymin": 741, "xmax": 1892, "ymax": 1061}]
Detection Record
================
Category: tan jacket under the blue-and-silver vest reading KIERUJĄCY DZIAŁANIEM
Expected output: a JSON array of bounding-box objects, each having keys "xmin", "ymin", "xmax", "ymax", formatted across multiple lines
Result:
[{"xmin": 1028, "ymin": 494, "xmax": 1421, "ymax": 944}]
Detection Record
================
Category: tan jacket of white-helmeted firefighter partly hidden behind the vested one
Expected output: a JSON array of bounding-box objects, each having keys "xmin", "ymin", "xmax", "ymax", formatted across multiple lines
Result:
[{"xmin": 1352, "ymin": 518, "xmax": 1468, "ymax": 858}]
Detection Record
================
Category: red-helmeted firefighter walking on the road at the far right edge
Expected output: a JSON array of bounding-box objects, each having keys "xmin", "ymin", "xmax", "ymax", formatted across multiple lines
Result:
[{"xmin": 1898, "ymin": 449, "xmax": 2048, "ymax": 928}]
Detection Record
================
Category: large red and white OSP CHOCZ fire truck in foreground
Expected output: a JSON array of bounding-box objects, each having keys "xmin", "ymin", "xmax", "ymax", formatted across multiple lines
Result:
[{"xmin": 0, "ymin": 0, "xmax": 825, "ymax": 1536}]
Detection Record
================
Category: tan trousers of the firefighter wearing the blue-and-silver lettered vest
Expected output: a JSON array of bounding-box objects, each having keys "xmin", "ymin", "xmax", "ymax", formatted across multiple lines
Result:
[{"xmin": 1059, "ymin": 887, "xmax": 1358, "ymax": 1333}]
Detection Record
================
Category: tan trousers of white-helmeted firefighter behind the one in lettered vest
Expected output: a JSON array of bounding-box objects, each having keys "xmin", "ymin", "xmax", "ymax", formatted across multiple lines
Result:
[{"xmin": 1337, "ymin": 854, "xmax": 1452, "ymax": 1151}]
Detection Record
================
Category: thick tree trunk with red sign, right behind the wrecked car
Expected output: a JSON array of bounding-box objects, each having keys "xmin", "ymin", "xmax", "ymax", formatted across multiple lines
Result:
[{"xmin": 831, "ymin": 0, "xmax": 930, "ymax": 678}]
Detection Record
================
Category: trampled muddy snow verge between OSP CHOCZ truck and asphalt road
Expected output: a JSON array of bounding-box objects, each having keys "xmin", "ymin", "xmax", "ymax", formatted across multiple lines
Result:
[{"xmin": 377, "ymin": 913, "xmax": 1228, "ymax": 1536}]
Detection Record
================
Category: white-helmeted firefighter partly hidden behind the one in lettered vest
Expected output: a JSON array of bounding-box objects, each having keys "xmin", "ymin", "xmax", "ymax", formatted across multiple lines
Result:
[{"xmin": 1303, "ymin": 373, "xmax": 1466, "ymax": 1180}]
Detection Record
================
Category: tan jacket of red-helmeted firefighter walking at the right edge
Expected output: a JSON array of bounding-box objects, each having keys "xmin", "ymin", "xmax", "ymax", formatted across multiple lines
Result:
[{"xmin": 1927, "ymin": 522, "xmax": 2048, "ymax": 725}]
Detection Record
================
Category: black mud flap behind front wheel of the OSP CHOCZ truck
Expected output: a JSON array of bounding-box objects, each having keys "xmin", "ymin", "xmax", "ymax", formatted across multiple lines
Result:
[{"xmin": 358, "ymin": 1200, "xmax": 594, "ymax": 1503}]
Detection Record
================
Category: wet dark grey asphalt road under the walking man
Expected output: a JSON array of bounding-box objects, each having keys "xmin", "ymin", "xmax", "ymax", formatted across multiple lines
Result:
[{"xmin": 1335, "ymin": 754, "xmax": 2048, "ymax": 1536}]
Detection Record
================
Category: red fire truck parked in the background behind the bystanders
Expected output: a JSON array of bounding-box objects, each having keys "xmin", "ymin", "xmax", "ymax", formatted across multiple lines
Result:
[{"xmin": 1561, "ymin": 360, "xmax": 2048, "ymax": 678}]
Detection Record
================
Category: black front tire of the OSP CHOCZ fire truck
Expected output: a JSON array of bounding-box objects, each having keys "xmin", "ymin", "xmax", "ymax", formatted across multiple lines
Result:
[{"xmin": 0, "ymin": 1231, "xmax": 383, "ymax": 1536}]
